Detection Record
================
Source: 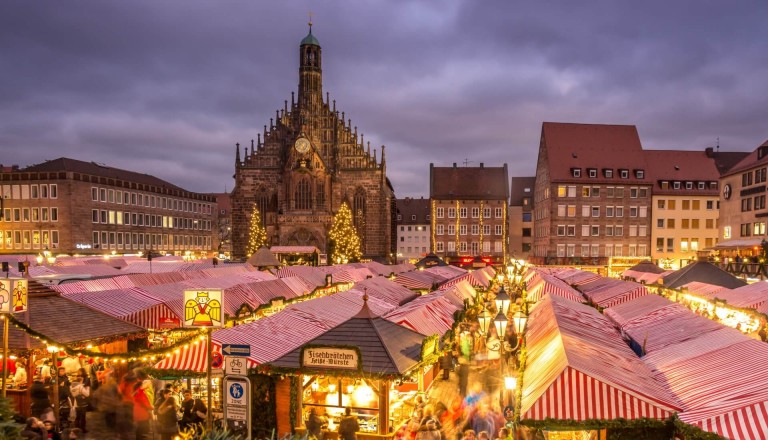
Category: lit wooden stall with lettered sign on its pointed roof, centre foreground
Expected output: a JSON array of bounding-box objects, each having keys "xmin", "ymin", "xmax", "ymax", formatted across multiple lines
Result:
[{"xmin": 268, "ymin": 296, "xmax": 438, "ymax": 438}]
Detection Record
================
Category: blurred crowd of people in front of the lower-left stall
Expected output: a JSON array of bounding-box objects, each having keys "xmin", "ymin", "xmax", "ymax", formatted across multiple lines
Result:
[{"xmin": 22, "ymin": 360, "xmax": 208, "ymax": 440}]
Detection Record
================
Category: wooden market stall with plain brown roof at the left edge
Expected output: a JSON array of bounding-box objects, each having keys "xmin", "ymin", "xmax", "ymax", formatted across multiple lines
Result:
[{"xmin": 5, "ymin": 280, "xmax": 147, "ymax": 416}]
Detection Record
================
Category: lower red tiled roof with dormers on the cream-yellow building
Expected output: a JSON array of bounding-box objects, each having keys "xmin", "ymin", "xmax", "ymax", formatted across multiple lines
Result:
[{"xmin": 645, "ymin": 150, "xmax": 720, "ymax": 194}]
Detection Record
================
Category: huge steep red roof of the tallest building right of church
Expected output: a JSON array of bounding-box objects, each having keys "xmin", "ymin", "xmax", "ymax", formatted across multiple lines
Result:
[{"xmin": 541, "ymin": 122, "xmax": 650, "ymax": 183}]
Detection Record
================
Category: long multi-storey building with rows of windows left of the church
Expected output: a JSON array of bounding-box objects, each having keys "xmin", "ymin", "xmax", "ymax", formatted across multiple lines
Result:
[{"xmin": 0, "ymin": 158, "xmax": 216, "ymax": 255}]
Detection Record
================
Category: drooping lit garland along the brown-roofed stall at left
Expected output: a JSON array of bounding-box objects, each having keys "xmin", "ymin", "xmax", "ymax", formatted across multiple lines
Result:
[{"xmin": 10, "ymin": 316, "xmax": 210, "ymax": 363}]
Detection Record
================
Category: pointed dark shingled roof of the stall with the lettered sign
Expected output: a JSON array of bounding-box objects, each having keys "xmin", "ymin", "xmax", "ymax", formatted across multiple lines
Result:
[{"xmin": 270, "ymin": 301, "xmax": 425, "ymax": 375}]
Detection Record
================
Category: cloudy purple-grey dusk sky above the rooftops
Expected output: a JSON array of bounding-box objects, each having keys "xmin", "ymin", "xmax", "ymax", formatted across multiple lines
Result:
[{"xmin": 0, "ymin": 0, "xmax": 768, "ymax": 197}]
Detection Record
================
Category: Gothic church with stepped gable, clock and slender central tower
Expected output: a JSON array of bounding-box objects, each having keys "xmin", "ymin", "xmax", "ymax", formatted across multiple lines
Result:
[{"xmin": 232, "ymin": 27, "xmax": 395, "ymax": 261}]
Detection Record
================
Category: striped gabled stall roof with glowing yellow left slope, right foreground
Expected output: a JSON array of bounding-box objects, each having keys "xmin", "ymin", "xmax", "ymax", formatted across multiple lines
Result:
[{"xmin": 521, "ymin": 296, "xmax": 681, "ymax": 421}]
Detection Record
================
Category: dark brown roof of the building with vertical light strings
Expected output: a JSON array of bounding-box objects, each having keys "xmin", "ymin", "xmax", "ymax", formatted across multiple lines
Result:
[{"xmin": 429, "ymin": 164, "xmax": 509, "ymax": 200}]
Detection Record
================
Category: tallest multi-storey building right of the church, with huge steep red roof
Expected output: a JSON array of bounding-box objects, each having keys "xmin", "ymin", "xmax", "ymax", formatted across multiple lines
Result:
[{"xmin": 531, "ymin": 122, "xmax": 653, "ymax": 265}]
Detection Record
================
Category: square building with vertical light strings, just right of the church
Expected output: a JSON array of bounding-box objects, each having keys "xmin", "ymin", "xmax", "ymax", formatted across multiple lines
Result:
[{"xmin": 429, "ymin": 163, "xmax": 509, "ymax": 265}]
